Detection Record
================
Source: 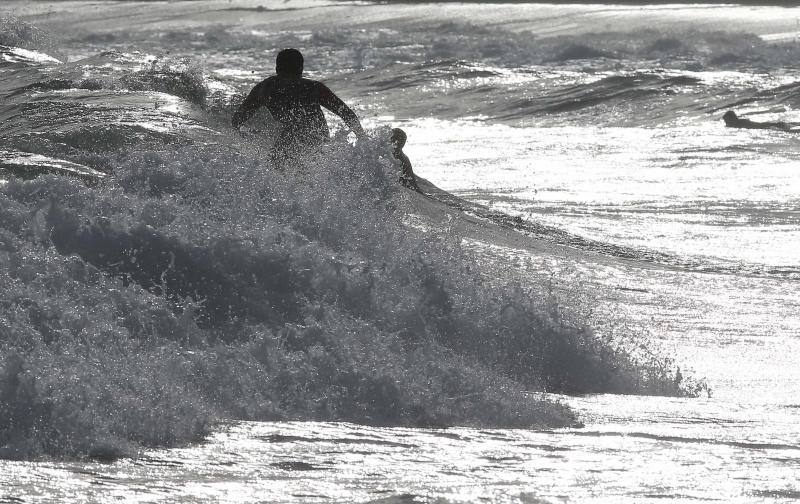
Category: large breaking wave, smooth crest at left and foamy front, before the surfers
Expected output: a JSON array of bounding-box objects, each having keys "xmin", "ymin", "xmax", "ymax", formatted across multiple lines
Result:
[{"xmin": 0, "ymin": 18, "xmax": 696, "ymax": 458}]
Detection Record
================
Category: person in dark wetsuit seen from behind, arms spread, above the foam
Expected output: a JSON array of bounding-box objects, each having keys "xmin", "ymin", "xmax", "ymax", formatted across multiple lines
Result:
[{"xmin": 231, "ymin": 49, "xmax": 366, "ymax": 163}]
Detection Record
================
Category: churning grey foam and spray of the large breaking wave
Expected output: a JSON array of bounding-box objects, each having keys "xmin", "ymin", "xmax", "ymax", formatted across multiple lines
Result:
[{"xmin": 2, "ymin": 142, "xmax": 688, "ymax": 456}]
